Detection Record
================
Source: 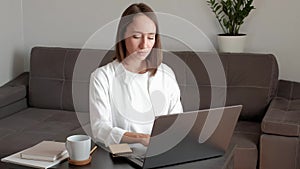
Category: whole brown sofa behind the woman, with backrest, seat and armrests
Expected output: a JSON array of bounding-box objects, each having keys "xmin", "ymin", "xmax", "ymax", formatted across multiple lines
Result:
[{"xmin": 0, "ymin": 47, "xmax": 300, "ymax": 169}]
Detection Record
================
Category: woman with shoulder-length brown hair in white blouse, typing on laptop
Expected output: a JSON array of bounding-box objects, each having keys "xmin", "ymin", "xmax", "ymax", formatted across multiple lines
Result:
[{"xmin": 90, "ymin": 3, "xmax": 182, "ymax": 146}]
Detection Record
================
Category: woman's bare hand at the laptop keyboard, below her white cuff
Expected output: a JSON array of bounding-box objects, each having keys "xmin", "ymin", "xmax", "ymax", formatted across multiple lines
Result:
[{"xmin": 121, "ymin": 132, "xmax": 150, "ymax": 146}]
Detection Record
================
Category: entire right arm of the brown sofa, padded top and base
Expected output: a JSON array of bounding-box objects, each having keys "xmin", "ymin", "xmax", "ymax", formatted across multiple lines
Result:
[{"xmin": 260, "ymin": 80, "xmax": 300, "ymax": 169}]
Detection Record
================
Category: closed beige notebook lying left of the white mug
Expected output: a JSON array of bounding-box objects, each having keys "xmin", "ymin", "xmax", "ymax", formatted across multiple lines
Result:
[{"xmin": 20, "ymin": 141, "xmax": 67, "ymax": 161}]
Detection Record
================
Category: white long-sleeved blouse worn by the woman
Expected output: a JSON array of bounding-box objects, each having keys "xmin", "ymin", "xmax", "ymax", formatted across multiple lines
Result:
[{"xmin": 89, "ymin": 61, "xmax": 183, "ymax": 146}]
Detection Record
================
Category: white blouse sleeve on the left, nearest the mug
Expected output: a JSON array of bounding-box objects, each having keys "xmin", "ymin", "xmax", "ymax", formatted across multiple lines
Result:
[{"xmin": 89, "ymin": 70, "xmax": 126, "ymax": 146}]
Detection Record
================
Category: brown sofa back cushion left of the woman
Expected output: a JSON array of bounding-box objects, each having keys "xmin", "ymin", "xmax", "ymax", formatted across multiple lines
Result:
[{"xmin": 29, "ymin": 47, "xmax": 113, "ymax": 112}]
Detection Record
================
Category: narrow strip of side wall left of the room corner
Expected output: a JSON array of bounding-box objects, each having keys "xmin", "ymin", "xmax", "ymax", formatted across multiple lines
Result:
[{"xmin": 0, "ymin": 0, "xmax": 25, "ymax": 86}]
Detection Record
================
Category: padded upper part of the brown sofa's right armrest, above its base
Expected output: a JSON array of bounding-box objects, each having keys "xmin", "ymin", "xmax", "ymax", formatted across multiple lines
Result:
[{"xmin": 261, "ymin": 80, "xmax": 300, "ymax": 137}]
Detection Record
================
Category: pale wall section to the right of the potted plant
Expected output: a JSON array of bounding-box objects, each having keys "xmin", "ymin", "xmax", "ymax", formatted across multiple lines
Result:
[{"xmin": 244, "ymin": 0, "xmax": 300, "ymax": 82}]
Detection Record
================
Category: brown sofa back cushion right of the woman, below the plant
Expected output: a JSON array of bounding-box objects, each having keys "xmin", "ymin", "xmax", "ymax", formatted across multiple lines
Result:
[{"xmin": 164, "ymin": 52, "xmax": 278, "ymax": 121}]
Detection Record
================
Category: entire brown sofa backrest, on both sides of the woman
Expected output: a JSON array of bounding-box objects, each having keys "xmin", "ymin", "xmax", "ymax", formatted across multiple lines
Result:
[{"xmin": 29, "ymin": 47, "xmax": 278, "ymax": 121}]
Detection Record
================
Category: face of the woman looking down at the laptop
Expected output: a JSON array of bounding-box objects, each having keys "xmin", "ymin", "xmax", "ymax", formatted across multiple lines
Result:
[{"xmin": 125, "ymin": 14, "xmax": 156, "ymax": 61}]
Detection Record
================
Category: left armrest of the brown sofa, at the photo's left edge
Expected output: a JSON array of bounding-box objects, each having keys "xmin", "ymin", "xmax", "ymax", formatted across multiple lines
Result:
[{"xmin": 0, "ymin": 73, "xmax": 28, "ymax": 118}]
